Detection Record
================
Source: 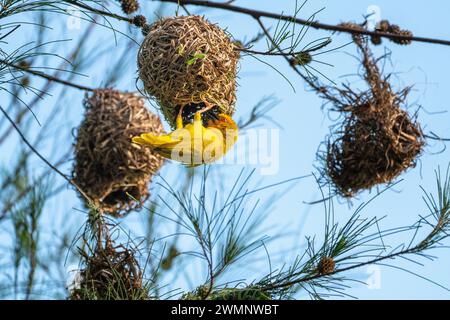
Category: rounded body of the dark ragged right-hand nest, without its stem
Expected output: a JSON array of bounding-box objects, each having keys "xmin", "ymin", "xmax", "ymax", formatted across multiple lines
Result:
[{"xmin": 326, "ymin": 100, "xmax": 424, "ymax": 197}]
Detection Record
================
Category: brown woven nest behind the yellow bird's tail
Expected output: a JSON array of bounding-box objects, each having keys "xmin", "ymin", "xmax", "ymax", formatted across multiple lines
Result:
[{"xmin": 73, "ymin": 89, "xmax": 164, "ymax": 216}]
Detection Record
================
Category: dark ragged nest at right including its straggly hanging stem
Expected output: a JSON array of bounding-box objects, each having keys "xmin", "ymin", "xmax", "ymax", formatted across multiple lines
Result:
[{"xmin": 310, "ymin": 36, "xmax": 425, "ymax": 197}]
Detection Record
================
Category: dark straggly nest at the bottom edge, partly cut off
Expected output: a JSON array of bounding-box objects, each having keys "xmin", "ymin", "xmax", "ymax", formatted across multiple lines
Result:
[{"xmin": 69, "ymin": 241, "xmax": 149, "ymax": 300}]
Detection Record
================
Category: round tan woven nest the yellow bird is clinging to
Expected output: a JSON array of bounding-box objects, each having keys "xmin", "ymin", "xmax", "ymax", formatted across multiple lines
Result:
[{"xmin": 138, "ymin": 16, "xmax": 239, "ymax": 127}]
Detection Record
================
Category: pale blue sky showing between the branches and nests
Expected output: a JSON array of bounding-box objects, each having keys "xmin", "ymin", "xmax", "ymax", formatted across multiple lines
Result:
[{"xmin": 0, "ymin": 0, "xmax": 450, "ymax": 299}]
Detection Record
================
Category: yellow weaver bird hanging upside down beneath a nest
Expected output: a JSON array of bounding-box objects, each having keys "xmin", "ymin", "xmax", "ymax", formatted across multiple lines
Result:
[{"xmin": 132, "ymin": 109, "xmax": 238, "ymax": 167}]
